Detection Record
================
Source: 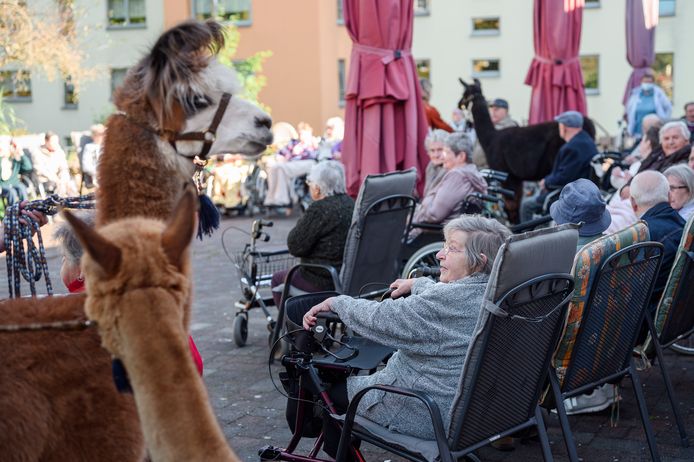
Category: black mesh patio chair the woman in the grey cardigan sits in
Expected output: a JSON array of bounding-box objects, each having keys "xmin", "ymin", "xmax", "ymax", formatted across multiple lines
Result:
[{"xmin": 333, "ymin": 225, "xmax": 577, "ymax": 462}]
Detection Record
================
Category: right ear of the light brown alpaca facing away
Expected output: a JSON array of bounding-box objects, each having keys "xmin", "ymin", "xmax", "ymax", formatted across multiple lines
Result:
[{"xmin": 161, "ymin": 187, "xmax": 198, "ymax": 269}]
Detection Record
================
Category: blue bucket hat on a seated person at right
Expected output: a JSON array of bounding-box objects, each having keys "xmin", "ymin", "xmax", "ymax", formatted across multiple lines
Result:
[{"xmin": 549, "ymin": 178, "xmax": 612, "ymax": 237}]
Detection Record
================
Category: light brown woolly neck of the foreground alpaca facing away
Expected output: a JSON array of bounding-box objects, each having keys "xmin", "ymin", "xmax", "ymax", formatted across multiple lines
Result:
[{"xmin": 109, "ymin": 288, "xmax": 238, "ymax": 461}]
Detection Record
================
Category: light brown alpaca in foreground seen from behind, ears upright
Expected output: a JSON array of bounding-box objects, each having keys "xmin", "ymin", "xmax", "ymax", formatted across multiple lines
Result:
[{"xmin": 65, "ymin": 189, "xmax": 238, "ymax": 461}]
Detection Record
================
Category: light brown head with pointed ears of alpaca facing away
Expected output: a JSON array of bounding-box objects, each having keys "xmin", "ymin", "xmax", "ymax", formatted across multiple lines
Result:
[{"xmin": 63, "ymin": 189, "xmax": 196, "ymax": 357}]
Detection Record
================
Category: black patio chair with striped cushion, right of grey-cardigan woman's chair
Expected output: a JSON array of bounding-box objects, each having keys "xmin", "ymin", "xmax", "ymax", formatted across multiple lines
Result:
[{"xmin": 550, "ymin": 239, "xmax": 663, "ymax": 461}]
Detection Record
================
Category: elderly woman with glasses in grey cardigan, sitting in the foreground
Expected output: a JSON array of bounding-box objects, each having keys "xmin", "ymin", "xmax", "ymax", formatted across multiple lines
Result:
[{"xmin": 303, "ymin": 215, "xmax": 510, "ymax": 454}]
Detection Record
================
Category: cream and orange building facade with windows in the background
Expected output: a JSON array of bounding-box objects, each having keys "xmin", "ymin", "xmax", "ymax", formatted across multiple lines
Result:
[{"xmin": 3, "ymin": 0, "xmax": 694, "ymax": 143}]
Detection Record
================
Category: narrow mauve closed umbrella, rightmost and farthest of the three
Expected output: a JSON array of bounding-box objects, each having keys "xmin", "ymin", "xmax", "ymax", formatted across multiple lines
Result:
[{"xmin": 622, "ymin": 0, "xmax": 658, "ymax": 105}]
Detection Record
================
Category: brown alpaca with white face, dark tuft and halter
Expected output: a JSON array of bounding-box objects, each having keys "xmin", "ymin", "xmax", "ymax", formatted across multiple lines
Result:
[{"xmin": 0, "ymin": 22, "xmax": 272, "ymax": 462}]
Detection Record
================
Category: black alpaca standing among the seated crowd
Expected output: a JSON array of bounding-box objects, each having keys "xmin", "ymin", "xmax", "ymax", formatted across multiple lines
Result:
[{"xmin": 458, "ymin": 79, "xmax": 595, "ymax": 223}]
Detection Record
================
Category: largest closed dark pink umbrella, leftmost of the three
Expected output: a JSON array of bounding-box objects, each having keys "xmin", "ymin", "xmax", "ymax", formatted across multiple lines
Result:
[{"xmin": 342, "ymin": 0, "xmax": 429, "ymax": 196}]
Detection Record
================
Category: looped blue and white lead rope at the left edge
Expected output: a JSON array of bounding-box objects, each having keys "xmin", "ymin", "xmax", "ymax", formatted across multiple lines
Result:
[{"xmin": 2, "ymin": 193, "xmax": 95, "ymax": 298}]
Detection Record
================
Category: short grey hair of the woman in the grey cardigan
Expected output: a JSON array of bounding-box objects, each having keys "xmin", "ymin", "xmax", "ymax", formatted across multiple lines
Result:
[{"xmin": 443, "ymin": 215, "xmax": 511, "ymax": 274}]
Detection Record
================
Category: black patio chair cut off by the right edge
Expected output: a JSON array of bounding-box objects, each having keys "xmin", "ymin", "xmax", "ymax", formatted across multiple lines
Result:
[{"xmin": 634, "ymin": 216, "xmax": 694, "ymax": 447}]
